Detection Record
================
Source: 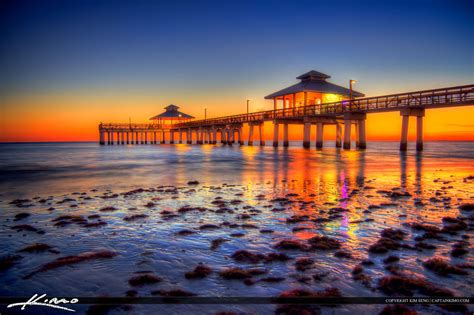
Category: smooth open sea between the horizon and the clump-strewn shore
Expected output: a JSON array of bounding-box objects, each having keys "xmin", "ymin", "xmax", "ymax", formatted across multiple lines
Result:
[{"xmin": 0, "ymin": 141, "xmax": 474, "ymax": 197}]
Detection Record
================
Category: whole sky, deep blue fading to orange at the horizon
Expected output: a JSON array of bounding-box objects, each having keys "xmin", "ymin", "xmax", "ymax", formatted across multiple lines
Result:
[{"xmin": 0, "ymin": 0, "xmax": 474, "ymax": 142}]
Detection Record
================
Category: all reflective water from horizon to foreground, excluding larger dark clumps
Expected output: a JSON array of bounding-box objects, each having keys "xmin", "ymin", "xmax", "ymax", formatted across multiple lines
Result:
[{"xmin": 0, "ymin": 142, "xmax": 474, "ymax": 314}]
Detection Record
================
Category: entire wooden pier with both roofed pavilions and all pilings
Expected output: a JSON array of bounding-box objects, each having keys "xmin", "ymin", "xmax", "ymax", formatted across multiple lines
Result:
[{"xmin": 99, "ymin": 70, "xmax": 474, "ymax": 151}]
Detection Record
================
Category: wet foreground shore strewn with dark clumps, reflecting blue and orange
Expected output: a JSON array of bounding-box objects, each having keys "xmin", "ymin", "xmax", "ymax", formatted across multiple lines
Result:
[{"xmin": 0, "ymin": 143, "xmax": 474, "ymax": 314}]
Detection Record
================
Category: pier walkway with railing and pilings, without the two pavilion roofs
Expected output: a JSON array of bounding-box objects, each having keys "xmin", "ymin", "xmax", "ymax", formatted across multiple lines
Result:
[{"xmin": 99, "ymin": 84, "xmax": 474, "ymax": 151}]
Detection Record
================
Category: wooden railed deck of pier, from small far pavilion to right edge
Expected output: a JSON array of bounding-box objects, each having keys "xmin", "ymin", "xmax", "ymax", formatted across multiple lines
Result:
[{"xmin": 173, "ymin": 84, "xmax": 474, "ymax": 128}]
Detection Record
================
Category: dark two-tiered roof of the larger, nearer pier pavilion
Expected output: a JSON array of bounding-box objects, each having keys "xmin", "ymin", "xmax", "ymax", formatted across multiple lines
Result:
[{"xmin": 265, "ymin": 70, "xmax": 364, "ymax": 99}]
